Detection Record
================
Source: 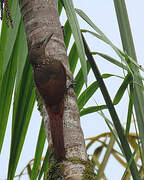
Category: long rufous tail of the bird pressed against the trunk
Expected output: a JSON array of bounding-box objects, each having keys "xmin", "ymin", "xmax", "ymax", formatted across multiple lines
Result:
[{"xmin": 46, "ymin": 103, "xmax": 65, "ymax": 159}]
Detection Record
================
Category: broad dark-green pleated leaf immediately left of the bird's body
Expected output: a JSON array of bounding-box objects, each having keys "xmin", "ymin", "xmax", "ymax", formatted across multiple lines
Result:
[{"xmin": 7, "ymin": 59, "xmax": 35, "ymax": 180}]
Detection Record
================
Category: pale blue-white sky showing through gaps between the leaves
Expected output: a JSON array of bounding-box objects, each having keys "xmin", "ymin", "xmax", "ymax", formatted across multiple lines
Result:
[{"xmin": 0, "ymin": 0, "xmax": 144, "ymax": 180}]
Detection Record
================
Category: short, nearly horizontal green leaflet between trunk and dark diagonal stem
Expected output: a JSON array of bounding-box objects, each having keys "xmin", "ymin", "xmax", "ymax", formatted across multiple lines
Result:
[{"xmin": 80, "ymin": 105, "xmax": 107, "ymax": 117}]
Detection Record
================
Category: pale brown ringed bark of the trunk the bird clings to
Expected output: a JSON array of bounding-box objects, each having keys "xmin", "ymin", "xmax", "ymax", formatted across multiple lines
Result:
[{"xmin": 19, "ymin": 0, "xmax": 87, "ymax": 180}]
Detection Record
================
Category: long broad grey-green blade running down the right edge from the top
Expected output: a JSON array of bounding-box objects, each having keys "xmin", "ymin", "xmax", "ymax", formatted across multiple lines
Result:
[{"xmin": 114, "ymin": 0, "xmax": 144, "ymax": 161}]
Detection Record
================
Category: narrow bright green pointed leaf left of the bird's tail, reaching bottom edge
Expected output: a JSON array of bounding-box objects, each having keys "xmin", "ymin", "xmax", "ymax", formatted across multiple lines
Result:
[{"xmin": 30, "ymin": 120, "xmax": 46, "ymax": 180}]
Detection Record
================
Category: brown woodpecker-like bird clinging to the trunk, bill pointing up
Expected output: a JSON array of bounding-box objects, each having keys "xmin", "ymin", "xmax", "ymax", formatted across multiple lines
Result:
[{"xmin": 29, "ymin": 34, "xmax": 66, "ymax": 160}]
